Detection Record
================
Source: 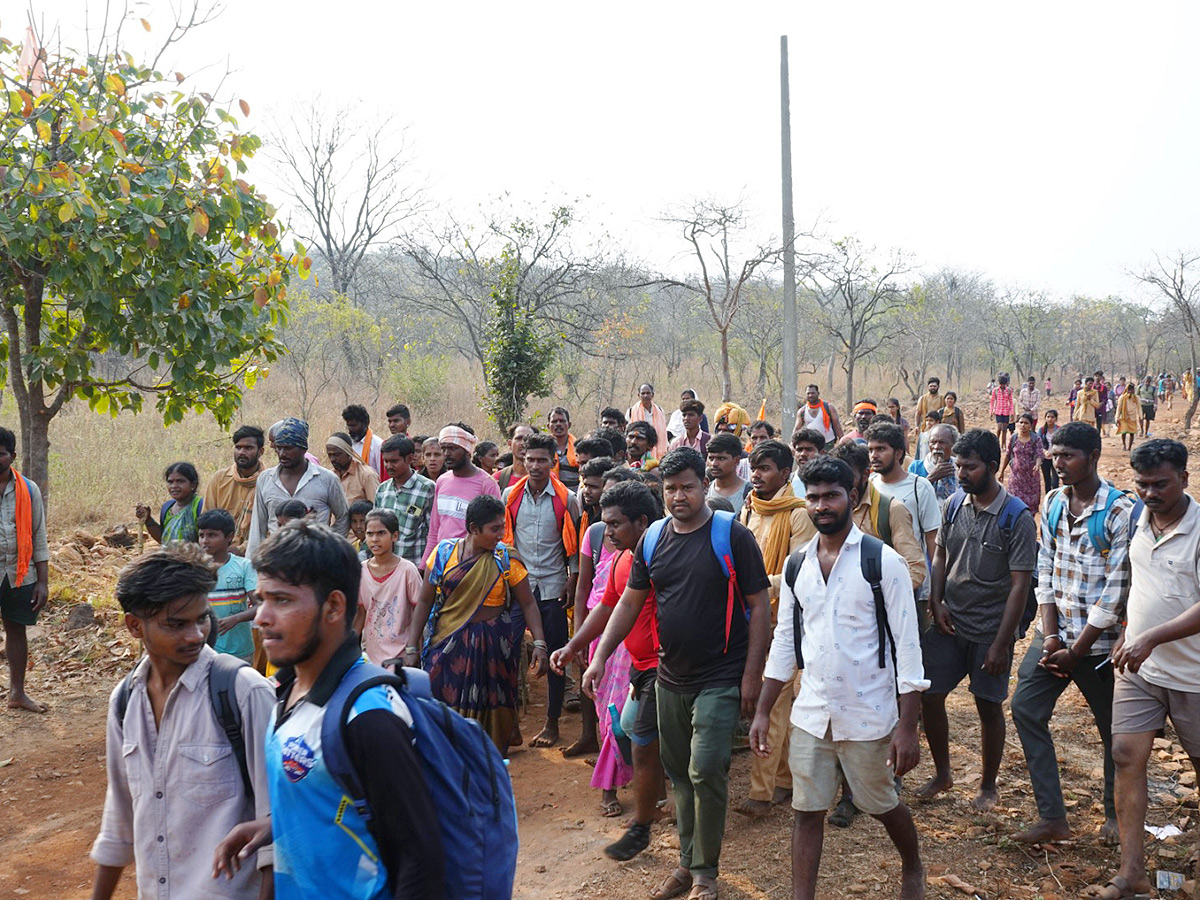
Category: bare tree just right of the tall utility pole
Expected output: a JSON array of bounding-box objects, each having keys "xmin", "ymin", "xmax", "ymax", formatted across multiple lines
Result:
[{"xmin": 800, "ymin": 238, "xmax": 912, "ymax": 409}]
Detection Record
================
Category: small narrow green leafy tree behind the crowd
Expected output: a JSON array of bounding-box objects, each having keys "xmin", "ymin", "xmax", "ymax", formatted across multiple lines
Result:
[{"xmin": 484, "ymin": 247, "xmax": 554, "ymax": 431}]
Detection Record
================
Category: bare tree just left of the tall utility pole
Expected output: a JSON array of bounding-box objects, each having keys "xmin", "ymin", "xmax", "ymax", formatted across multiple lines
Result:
[{"xmin": 664, "ymin": 199, "xmax": 782, "ymax": 401}]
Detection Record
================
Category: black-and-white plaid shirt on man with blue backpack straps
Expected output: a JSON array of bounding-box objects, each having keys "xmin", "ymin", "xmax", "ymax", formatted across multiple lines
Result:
[{"xmin": 1037, "ymin": 482, "xmax": 1133, "ymax": 656}]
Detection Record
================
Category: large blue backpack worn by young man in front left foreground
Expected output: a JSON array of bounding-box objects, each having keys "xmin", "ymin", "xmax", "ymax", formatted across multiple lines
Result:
[{"xmin": 320, "ymin": 662, "xmax": 517, "ymax": 900}]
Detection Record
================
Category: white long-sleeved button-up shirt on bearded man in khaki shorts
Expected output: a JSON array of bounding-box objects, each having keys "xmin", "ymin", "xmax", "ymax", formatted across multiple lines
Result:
[{"xmin": 763, "ymin": 526, "xmax": 929, "ymax": 740}]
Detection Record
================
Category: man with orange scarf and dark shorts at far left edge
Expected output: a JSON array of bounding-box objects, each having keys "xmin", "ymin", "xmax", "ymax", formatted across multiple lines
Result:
[{"xmin": 0, "ymin": 428, "xmax": 50, "ymax": 713}]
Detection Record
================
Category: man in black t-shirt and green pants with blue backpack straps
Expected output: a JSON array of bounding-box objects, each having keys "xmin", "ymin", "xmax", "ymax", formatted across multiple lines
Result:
[{"xmin": 583, "ymin": 449, "xmax": 770, "ymax": 900}]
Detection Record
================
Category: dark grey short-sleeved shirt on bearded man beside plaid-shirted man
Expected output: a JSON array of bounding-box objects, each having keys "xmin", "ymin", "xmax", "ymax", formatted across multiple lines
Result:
[{"xmin": 937, "ymin": 487, "xmax": 1038, "ymax": 643}]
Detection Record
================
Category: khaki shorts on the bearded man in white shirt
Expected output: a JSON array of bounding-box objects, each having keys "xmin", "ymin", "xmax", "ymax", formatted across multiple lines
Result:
[{"xmin": 787, "ymin": 725, "xmax": 900, "ymax": 816}]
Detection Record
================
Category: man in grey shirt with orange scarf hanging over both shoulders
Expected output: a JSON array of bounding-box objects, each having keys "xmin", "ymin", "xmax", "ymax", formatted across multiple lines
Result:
[{"xmin": 500, "ymin": 434, "xmax": 580, "ymax": 746}]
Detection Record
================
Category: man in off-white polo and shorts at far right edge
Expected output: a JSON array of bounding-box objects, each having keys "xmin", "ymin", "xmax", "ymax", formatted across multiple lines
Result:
[{"xmin": 1104, "ymin": 438, "xmax": 1200, "ymax": 896}]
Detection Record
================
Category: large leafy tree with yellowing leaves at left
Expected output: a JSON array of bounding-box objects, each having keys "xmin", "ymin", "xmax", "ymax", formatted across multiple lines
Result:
[{"xmin": 0, "ymin": 10, "xmax": 302, "ymax": 490}]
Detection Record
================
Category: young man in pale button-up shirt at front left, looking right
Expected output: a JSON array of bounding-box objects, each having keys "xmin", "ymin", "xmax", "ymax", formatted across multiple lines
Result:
[{"xmin": 91, "ymin": 547, "xmax": 274, "ymax": 900}]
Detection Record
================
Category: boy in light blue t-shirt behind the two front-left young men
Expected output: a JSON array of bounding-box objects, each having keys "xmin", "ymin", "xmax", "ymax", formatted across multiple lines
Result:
[{"xmin": 196, "ymin": 509, "xmax": 258, "ymax": 662}]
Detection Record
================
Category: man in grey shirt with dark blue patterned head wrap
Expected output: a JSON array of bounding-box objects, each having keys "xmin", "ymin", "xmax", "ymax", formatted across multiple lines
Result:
[{"xmin": 246, "ymin": 416, "xmax": 350, "ymax": 556}]
